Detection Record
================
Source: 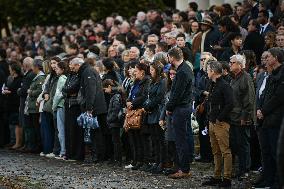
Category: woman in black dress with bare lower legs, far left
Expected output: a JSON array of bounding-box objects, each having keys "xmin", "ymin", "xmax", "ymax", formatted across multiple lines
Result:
[{"xmin": 2, "ymin": 62, "xmax": 23, "ymax": 149}]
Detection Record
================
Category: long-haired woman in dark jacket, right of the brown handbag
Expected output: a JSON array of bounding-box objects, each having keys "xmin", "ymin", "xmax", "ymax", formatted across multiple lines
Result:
[{"xmin": 144, "ymin": 61, "xmax": 166, "ymax": 173}]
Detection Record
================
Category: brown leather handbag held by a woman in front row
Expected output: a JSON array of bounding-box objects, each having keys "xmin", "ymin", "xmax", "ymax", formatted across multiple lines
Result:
[{"xmin": 124, "ymin": 108, "xmax": 145, "ymax": 131}]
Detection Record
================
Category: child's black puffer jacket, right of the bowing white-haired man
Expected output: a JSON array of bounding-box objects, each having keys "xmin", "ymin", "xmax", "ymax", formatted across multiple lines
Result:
[{"xmin": 107, "ymin": 93, "xmax": 123, "ymax": 128}]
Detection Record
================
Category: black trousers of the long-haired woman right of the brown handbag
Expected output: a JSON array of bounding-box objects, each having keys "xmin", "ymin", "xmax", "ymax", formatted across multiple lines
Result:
[{"xmin": 151, "ymin": 124, "xmax": 166, "ymax": 164}]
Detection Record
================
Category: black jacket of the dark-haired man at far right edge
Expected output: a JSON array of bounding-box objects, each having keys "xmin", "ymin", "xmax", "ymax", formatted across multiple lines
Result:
[{"xmin": 261, "ymin": 65, "xmax": 284, "ymax": 128}]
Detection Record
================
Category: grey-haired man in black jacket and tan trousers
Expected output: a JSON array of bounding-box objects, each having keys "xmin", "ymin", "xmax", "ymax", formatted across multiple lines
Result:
[{"xmin": 202, "ymin": 61, "xmax": 233, "ymax": 187}]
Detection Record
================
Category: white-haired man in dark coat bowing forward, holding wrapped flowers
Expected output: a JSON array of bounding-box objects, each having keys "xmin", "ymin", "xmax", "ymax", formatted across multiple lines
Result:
[{"xmin": 70, "ymin": 58, "xmax": 109, "ymax": 162}]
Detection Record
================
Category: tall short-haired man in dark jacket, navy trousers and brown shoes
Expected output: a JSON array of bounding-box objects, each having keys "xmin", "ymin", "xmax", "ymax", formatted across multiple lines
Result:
[{"xmin": 166, "ymin": 47, "xmax": 194, "ymax": 179}]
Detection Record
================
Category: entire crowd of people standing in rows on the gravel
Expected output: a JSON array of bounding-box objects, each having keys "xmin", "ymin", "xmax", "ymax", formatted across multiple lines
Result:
[{"xmin": 0, "ymin": 0, "xmax": 284, "ymax": 188}]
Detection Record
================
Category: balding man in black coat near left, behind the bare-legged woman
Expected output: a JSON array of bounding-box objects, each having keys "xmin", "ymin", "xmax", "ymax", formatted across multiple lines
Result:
[{"xmin": 17, "ymin": 57, "xmax": 36, "ymax": 148}]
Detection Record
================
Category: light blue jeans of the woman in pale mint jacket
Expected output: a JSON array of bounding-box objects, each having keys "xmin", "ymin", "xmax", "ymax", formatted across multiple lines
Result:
[{"xmin": 56, "ymin": 108, "xmax": 66, "ymax": 155}]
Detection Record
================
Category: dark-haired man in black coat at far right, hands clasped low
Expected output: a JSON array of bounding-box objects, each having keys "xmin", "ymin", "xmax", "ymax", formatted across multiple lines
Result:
[{"xmin": 257, "ymin": 47, "xmax": 284, "ymax": 188}]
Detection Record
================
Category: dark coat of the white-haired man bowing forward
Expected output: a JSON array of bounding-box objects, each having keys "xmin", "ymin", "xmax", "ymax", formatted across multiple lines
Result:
[{"xmin": 79, "ymin": 63, "xmax": 107, "ymax": 115}]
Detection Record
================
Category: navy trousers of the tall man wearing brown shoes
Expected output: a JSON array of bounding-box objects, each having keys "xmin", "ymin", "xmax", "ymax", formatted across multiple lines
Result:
[{"xmin": 172, "ymin": 106, "xmax": 193, "ymax": 173}]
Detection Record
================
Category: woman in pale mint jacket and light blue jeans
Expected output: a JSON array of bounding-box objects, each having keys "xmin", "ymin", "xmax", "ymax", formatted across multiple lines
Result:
[{"xmin": 52, "ymin": 61, "xmax": 68, "ymax": 159}]
